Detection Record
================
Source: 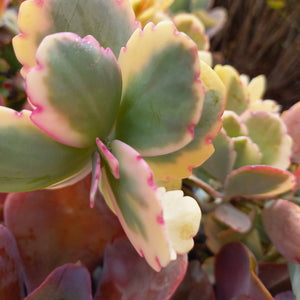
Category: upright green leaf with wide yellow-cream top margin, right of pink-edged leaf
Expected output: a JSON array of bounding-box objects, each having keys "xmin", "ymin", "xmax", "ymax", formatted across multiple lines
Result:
[{"xmin": 115, "ymin": 22, "xmax": 204, "ymax": 156}]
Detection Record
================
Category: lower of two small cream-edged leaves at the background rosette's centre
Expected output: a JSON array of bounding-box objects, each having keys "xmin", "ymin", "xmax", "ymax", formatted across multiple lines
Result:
[{"xmin": 232, "ymin": 136, "xmax": 262, "ymax": 169}]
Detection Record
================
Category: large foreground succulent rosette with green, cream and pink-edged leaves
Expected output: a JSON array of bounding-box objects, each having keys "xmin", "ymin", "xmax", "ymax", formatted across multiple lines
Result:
[{"xmin": 0, "ymin": 0, "xmax": 223, "ymax": 270}]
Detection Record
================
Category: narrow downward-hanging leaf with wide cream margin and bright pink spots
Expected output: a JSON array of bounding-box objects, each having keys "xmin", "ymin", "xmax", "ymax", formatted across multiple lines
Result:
[{"xmin": 102, "ymin": 140, "xmax": 173, "ymax": 271}]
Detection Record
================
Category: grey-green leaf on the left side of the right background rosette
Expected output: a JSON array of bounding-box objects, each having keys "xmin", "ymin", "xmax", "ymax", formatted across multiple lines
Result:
[{"xmin": 201, "ymin": 129, "xmax": 236, "ymax": 182}]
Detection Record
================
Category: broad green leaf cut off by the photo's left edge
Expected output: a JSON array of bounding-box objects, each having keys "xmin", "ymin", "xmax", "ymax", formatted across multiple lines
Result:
[{"xmin": 0, "ymin": 107, "xmax": 92, "ymax": 192}]
